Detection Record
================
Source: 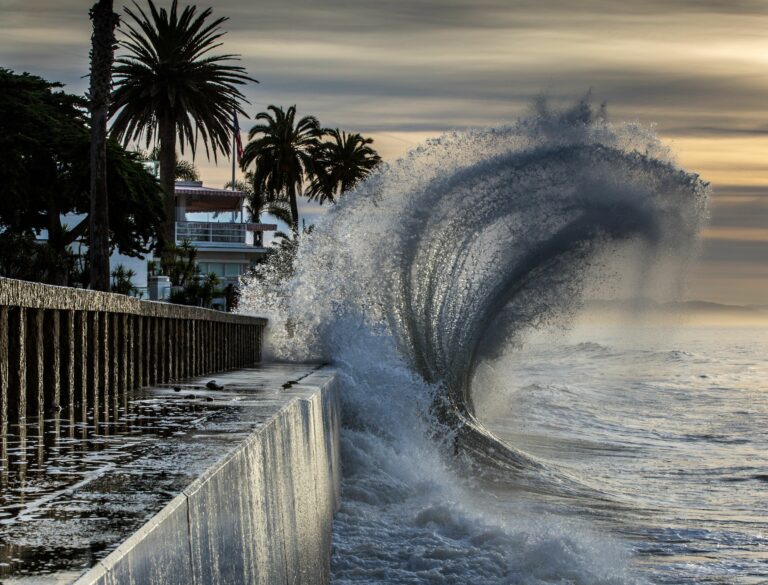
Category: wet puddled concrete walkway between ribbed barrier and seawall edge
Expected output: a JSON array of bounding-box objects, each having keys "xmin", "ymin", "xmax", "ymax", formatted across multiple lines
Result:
[{"xmin": 0, "ymin": 364, "xmax": 328, "ymax": 584}]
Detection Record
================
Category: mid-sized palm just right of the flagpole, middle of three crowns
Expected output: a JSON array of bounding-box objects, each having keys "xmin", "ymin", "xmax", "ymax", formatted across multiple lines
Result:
[{"xmin": 240, "ymin": 105, "xmax": 321, "ymax": 234}]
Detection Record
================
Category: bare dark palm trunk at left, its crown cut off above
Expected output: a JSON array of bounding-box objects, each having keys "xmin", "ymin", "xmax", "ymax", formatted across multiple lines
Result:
[{"xmin": 89, "ymin": 0, "xmax": 119, "ymax": 291}]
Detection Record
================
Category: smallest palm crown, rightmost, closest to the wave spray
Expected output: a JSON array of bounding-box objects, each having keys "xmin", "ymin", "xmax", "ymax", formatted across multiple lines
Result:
[{"xmin": 306, "ymin": 128, "xmax": 381, "ymax": 205}]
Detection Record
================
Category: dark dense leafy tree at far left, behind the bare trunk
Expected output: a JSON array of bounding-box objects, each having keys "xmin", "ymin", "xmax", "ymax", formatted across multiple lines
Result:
[{"xmin": 0, "ymin": 69, "xmax": 163, "ymax": 284}]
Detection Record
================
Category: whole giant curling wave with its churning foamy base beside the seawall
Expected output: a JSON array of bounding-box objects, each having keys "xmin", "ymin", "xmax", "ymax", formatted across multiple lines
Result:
[{"xmin": 241, "ymin": 101, "xmax": 707, "ymax": 584}]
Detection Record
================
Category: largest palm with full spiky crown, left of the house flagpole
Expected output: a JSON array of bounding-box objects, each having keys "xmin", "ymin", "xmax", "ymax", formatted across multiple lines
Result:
[{"xmin": 112, "ymin": 0, "xmax": 258, "ymax": 255}]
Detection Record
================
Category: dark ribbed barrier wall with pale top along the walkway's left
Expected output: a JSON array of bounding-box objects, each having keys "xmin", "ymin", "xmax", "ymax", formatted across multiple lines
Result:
[{"xmin": 0, "ymin": 278, "xmax": 266, "ymax": 438}]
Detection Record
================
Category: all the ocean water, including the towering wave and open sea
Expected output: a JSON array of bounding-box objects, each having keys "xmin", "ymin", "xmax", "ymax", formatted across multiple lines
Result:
[{"xmin": 236, "ymin": 102, "xmax": 768, "ymax": 585}]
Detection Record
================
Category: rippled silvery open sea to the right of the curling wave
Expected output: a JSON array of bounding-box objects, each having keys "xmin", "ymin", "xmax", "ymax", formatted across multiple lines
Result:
[{"xmin": 474, "ymin": 324, "xmax": 768, "ymax": 584}]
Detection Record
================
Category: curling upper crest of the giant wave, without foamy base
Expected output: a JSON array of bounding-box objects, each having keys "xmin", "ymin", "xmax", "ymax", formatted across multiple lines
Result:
[{"xmin": 242, "ymin": 100, "xmax": 708, "ymax": 428}]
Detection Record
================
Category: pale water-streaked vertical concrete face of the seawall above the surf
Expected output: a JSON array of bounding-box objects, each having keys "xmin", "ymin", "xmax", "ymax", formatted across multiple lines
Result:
[{"xmin": 76, "ymin": 370, "xmax": 341, "ymax": 585}]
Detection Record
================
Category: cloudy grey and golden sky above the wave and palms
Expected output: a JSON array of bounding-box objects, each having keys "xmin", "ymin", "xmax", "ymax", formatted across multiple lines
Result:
[{"xmin": 0, "ymin": 0, "xmax": 768, "ymax": 304}]
